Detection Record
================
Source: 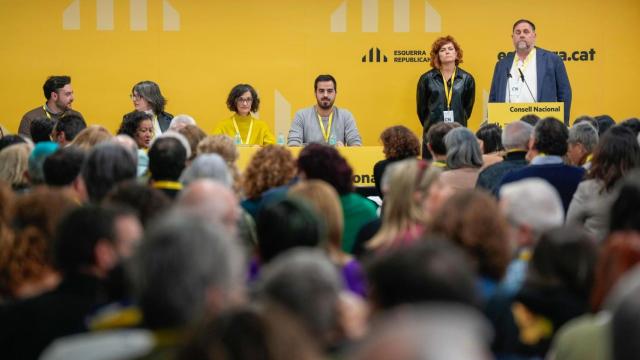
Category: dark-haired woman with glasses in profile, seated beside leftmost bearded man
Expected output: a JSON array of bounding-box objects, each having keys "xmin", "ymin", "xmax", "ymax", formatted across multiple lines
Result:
[{"xmin": 130, "ymin": 80, "xmax": 173, "ymax": 137}]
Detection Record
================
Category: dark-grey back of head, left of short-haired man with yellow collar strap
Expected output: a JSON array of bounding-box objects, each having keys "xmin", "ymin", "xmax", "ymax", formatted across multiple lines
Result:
[{"xmin": 82, "ymin": 143, "xmax": 137, "ymax": 202}]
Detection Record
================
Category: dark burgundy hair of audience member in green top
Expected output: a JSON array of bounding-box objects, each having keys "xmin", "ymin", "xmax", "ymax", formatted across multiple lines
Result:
[{"xmin": 298, "ymin": 144, "xmax": 353, "ymax": 195}]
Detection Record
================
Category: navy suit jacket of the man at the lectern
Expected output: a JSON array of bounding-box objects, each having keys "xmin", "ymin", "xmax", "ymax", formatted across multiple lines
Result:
[{"xmin": 489, "ymin": 47, "xmax": 571, "ymax": 126}]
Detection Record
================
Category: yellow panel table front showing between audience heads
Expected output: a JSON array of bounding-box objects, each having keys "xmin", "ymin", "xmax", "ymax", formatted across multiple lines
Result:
[{"xmin": 237, "ymin": 146, "xmax": 384, "ymax": 187}]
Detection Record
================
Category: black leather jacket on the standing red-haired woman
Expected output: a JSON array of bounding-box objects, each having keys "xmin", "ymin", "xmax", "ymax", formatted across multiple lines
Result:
[{"xmin": 416, "ymin": 68, "xmax": 476, "ymax": 133}]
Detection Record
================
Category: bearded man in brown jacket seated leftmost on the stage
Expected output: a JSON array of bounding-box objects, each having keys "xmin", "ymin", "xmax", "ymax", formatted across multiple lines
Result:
[{"xmin": 18, "ymin": 76, "xmax": 84, "ymax": 137}]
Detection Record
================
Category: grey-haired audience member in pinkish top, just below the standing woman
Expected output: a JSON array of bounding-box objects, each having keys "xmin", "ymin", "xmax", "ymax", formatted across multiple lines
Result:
[{"xmin": 441, "ymin": 127, "xmax": 482, "ymax": 191}]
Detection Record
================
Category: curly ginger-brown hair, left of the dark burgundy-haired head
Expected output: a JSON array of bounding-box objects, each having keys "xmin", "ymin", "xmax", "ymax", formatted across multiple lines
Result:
[{"xmin": 242, "ymin": 145, "xmax": 296, "ymax": 199}]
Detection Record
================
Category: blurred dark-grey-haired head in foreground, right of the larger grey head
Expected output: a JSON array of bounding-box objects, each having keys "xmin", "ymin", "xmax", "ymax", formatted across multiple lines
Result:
[{"xmin": 257, "ymin": 248, "xmax": 343, "ymax": 345}]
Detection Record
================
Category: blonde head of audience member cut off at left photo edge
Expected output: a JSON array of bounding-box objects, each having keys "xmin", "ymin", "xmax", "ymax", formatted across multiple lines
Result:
[{"xmin": 0, "ymin": 143, "xmax": 32, "ymax": 192}]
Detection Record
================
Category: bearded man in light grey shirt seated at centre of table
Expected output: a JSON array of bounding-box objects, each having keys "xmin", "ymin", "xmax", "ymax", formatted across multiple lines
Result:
[{"xmin": 287, "ymin": 75, "xmax": 362, "ymax": 146}]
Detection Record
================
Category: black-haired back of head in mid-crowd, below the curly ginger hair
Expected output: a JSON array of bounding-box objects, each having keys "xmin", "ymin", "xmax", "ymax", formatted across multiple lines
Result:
[{"xmin": 256, "ymin": 199, "xmax": 326, "ymax": 263}]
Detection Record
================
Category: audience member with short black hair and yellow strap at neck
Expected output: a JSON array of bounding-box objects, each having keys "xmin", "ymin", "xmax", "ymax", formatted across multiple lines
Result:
[{"xmin": 149, "ymin": 136, "xmax": 188, "ymax": 199}]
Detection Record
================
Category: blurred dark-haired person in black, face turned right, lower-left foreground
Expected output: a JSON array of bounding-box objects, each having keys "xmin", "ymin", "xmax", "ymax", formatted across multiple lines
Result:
[{"xmin": 0, "ymin": 205, "xmax": 139, "ymax": 359}]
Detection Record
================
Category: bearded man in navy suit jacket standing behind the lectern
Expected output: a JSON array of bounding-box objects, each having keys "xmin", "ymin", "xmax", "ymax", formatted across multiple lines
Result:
[{"xmin": 489, "ymin": 19, "xmax": 571, "ymax": 126}]
